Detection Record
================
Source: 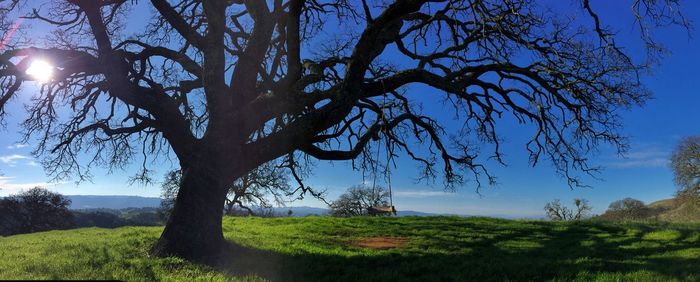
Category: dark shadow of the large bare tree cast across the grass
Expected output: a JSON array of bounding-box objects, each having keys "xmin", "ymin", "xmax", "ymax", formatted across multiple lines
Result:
[{"xmin": 215, "ymin": 221, "xmax": 700, "ymax": 281}]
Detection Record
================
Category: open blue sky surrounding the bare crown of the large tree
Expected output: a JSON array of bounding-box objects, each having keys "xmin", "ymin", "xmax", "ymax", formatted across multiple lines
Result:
[{"xmin": 0, "ymin": 1, "xmax": 700, "ymax": 217}]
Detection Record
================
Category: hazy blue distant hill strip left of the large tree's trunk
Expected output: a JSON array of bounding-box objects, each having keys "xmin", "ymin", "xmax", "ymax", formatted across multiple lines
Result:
[{"xmin": 66, "ymin": 195, "xmax": 161, "ymax": 210}]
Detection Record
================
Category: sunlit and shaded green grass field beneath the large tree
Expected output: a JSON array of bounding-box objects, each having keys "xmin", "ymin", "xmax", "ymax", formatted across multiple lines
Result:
[{"xmin": 0, "ymin": 217, "xmax": 700, "ymax": 281}]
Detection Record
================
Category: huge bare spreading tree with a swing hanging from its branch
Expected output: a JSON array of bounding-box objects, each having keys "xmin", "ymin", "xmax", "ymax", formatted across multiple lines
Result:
[{"xmin": 0, "ymin": 0, "xmax": 686, "ymax": 262}]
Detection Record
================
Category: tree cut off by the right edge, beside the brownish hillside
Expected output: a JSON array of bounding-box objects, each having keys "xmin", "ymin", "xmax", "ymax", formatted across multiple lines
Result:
[{"xmin": 671, "ymin": 136, "xmax": 700, "ymax": 199}]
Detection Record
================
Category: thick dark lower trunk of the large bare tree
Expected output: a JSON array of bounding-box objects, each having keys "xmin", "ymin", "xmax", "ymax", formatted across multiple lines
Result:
[{"xmin": 152, "ymin": 162, "xmax": 227, "ymax": 264}]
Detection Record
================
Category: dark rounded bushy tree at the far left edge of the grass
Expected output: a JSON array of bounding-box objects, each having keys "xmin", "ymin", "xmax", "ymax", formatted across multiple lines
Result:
[{"xmin": 0, "ymin": 187, "xmax": 75, "ymax": 236}]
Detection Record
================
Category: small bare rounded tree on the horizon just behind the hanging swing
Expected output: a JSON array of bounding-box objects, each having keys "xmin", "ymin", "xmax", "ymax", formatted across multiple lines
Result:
[{"xmin": 330, "ymin": 185, "xmax": 389, "ymax": 217}]
